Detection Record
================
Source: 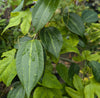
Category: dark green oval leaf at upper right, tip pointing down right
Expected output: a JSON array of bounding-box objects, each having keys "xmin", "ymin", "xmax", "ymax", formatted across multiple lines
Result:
[{"xmin": 63, "ymin": 13, "xmax": 85, "ymax": 37}]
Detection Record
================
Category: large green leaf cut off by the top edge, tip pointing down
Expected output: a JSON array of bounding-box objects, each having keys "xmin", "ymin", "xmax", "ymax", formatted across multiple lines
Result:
[{"xmin": 32, "ymin": 0, "xmax": 60, "ymax": 32}]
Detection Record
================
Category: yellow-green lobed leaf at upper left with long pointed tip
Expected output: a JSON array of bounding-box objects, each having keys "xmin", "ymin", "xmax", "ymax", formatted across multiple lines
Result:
[{"xmin": 2, "ymin": 10, "xmax": 32, "ymax": 35}]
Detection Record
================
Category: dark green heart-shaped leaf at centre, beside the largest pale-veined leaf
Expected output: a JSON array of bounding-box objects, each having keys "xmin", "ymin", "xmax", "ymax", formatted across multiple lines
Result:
[{"xmin": 40, "ymin": 27, "xmax": 63, "ymax": 58}]
